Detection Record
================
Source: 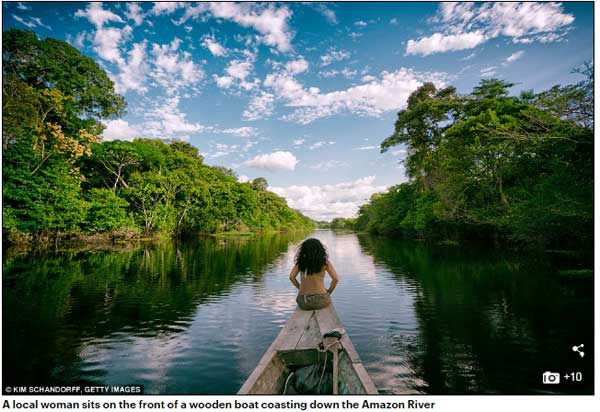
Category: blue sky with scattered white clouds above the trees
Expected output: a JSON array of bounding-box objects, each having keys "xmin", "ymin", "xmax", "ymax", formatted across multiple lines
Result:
[{"xmin": 2, "ymin": 2, "xmax": 593, "ymax": 220}]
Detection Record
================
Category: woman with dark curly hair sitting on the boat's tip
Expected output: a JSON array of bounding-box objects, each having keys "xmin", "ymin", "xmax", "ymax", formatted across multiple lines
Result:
[{"xmin": 290, "ymin": 239, "xmax": 338, "ymax": 310}]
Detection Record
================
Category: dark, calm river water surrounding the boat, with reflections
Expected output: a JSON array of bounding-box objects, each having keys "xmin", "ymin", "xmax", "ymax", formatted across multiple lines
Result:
[{"xmin": 2, "ymin": 230, "xmax": 594, "ymax": 394}]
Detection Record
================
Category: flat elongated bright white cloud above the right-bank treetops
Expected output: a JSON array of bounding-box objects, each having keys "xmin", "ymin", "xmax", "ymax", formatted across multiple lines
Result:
[{"xmin": 406, "ymin": 31, "xmax": 487, "ymax": 56}]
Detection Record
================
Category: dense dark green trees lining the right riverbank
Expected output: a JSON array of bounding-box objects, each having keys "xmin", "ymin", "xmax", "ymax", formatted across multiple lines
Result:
[{"xmin": 355, "ymin": 68, "xmax": 594, "ymax": 247}]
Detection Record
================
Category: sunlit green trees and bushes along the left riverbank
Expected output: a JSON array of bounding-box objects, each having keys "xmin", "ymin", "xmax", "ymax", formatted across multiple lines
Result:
[{"xmin": 2, "ymin": 30, "xmax": 314, "ymax": 243}]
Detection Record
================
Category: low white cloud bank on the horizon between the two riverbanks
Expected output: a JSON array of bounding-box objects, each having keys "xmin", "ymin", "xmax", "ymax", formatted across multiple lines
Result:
[{"xmin": 269, "ymin": 176, "xmax": 386, "ymax": 220}]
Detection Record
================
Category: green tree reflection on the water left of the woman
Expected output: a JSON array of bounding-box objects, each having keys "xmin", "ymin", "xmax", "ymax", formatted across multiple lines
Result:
[{"xmin": 3, "ymin": 233, "xmax": 308, "ymax": 384}]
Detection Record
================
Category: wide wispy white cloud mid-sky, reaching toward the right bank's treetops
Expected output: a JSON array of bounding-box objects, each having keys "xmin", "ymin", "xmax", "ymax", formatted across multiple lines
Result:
[{"xmin": 264, "ymin": 68, "xmax": 445, "ymax": 124}]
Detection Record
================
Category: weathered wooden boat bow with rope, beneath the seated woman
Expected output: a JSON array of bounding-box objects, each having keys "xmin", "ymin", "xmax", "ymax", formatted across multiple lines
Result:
[{"xmin": 238, "ymin": 305, "xmax": 378, "ymax": 395}]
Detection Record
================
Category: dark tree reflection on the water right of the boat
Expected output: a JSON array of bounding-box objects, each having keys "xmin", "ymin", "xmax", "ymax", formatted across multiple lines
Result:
[{"xmin": 359, "ymin": 236, "xmax": 593, "ymax": 394}]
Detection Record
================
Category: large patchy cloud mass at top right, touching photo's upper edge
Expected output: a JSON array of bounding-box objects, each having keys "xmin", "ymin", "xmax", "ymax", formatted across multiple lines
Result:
[{"xmin": 406, "ymin": 2, "xmax": 575, "ymax": 56}]
